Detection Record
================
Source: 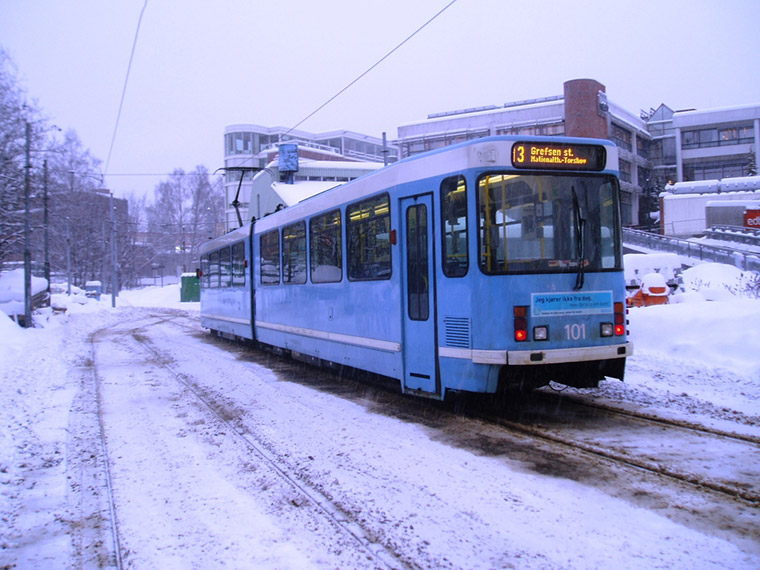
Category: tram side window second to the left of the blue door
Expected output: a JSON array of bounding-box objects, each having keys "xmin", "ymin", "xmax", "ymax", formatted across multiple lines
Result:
[{"xmin": 309, "ymin": 210, "xmax": 343, "ymax": 283}]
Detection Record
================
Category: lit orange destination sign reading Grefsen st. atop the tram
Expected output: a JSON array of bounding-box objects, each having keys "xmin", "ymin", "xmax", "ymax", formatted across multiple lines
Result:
[{"xmin": 512, "ymin": 142, "xmax": 607, "ymax": 171}]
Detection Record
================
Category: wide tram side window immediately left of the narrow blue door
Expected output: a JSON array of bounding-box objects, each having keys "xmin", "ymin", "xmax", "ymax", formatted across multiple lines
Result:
[{"xmin": 346, "ymin": 194, "xmax": 391, "ymax": 281}]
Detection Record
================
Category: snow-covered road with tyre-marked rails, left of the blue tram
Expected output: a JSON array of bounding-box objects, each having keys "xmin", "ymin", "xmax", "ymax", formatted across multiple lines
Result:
[{"xmin": 0, "ymin": 296, "xmax": 760, "ymax": 568}]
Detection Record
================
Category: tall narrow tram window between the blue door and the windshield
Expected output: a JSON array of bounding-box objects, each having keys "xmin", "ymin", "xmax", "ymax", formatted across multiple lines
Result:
[{"xmin": 441, "ymin": 176, "xmax": 470, "ymax": 277}]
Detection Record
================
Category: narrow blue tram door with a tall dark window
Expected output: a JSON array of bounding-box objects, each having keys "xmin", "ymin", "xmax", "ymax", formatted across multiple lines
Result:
[{"xmin": 400, "ymin": 194, "xmax": 440, "ymax": 394}]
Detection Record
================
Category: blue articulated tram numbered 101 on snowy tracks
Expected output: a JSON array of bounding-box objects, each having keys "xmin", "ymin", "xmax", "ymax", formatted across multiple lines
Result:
[{"xmin": 201, "ymin": 136, "xmax": 632, "ymax": 399}]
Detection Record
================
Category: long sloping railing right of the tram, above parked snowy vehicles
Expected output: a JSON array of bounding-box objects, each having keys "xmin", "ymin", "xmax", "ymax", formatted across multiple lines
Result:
[{"xmin": 623, "ymin": 228, "xmax": 760, "ymax": 271}]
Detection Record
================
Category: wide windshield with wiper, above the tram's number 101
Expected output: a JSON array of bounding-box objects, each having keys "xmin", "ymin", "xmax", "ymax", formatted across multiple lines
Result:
[{"xmin": 478, "ymin": 173, "xmax": 622, "ymax": 274}]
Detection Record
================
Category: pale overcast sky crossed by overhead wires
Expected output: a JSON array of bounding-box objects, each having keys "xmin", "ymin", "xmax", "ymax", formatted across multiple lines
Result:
[{"xmin": 0, "ymin": 0, "xmax": 760, "ymax": 200}]
